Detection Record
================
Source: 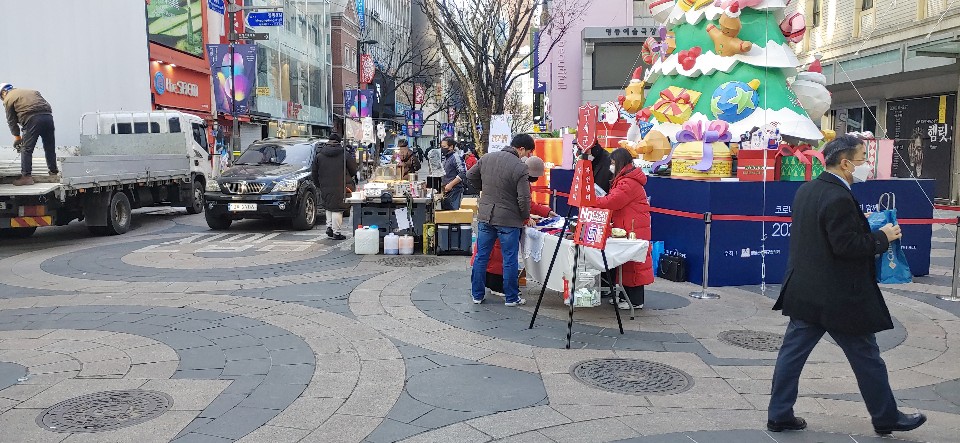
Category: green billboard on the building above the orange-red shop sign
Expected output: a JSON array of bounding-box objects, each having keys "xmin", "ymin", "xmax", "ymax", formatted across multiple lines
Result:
[{"xmin": 147, "ymin": 0, "xmax": 203, "ymax": 57}]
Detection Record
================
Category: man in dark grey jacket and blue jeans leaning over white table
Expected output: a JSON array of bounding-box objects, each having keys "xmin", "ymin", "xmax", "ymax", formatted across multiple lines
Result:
[{"xmin": 467, "ymin": 134, "xmax": 534, "ymax": 306}]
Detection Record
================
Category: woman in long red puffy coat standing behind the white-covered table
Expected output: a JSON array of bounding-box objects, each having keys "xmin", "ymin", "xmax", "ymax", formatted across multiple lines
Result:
[{"xmin": 595, "ymin": 148, "xmax": 653, "ymax": 309}]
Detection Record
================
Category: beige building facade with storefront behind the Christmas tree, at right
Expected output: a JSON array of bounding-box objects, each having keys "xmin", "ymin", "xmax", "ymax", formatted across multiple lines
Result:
[{"xmin": 796, "ymin": 0, "xmax": 960, "ymax": 202}]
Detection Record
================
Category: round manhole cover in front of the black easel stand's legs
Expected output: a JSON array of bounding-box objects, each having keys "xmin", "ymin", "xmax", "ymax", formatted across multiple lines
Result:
[{"xmin": 570, "ymin": 358, "xmax": 693, "ymax": 395}]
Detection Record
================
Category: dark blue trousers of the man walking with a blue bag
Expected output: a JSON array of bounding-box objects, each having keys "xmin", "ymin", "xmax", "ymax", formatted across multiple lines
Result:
[{"xmin": 767, "ymin": 318, "xmax": 900, "ymax": 426}]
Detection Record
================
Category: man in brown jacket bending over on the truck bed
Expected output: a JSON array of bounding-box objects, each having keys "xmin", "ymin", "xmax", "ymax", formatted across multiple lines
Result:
[{"xmin": 0, "ymin": 83, "xmax": 60, "ymax": 186}]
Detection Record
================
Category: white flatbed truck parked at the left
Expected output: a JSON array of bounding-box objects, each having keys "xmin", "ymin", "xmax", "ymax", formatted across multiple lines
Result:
[{"xmin": 0, "ymin": 111, "xmax": 212, "ymax": 238}]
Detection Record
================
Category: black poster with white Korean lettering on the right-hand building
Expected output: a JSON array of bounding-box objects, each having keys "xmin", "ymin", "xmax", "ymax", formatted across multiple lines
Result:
[{"xmin": 887, "ymin": 94, "xmax": 957, "ymax": 199}]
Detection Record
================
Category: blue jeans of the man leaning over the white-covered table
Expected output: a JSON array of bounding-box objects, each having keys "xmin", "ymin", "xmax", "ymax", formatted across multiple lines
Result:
[{"xmin": 470, "ymin": 222, "xmax": 521, "ymax": 303}]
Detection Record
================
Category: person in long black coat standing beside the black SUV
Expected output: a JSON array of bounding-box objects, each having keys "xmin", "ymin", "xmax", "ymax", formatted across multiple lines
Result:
[{"xmin": 316, "ymin": 134, "xmax": 357, "ymax": 240}]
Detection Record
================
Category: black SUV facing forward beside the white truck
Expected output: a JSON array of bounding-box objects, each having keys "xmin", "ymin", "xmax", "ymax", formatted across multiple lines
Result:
[{"xmin": 204, "ymin": 138, "xmax": 324, "ymax": 231}]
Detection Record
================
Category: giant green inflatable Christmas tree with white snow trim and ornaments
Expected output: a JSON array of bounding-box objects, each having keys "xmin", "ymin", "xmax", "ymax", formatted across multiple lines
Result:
[{"xmin": 638, "ymin": 0, "xmax": 829, "ymax": 140}]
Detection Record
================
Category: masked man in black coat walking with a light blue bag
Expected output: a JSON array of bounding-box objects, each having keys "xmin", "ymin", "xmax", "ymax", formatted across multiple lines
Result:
[{"xmin": 767, "ymin": 135, "xmax": 926, "ymax": 434}]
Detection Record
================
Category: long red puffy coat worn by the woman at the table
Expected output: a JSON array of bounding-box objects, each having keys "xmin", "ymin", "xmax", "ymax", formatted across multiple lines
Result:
[{"xmin": 595, "ymin": 165, "xmax": 653, "ymax": 287}]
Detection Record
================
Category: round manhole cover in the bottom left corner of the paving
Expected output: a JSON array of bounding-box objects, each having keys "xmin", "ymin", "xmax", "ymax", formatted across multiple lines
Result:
[{"xmin": 37, "ymin": 390, "xmax": 173, "ymax": 433}]
